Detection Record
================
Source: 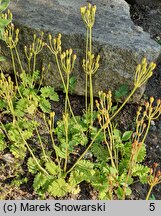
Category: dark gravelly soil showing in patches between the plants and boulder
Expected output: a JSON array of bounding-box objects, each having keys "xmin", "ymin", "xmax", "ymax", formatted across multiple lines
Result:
[{"xmin": 0, "ymin": 0, "xmax": 161, "ymax": 200}]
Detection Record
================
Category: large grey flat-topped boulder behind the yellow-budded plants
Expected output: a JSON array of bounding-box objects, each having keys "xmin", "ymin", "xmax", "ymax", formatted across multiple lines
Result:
[{"xmin": 1, "ymin": 0, "xmax": 161, "ymax": 102}]
